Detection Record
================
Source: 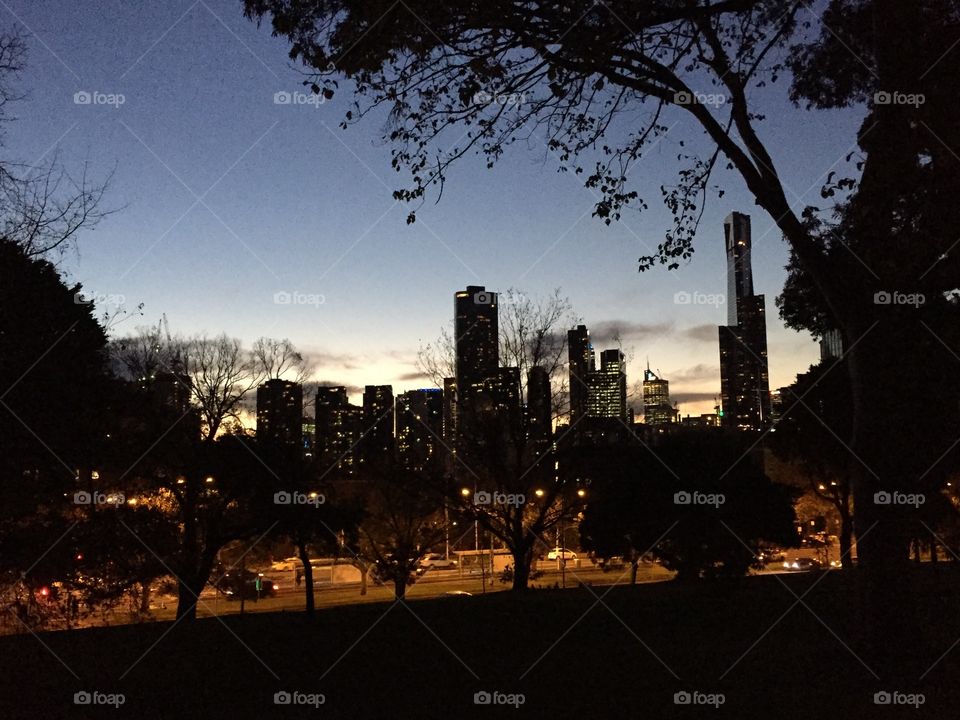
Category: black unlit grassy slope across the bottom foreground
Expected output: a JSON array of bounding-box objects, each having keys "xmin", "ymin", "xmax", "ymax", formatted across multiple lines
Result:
[{"xmin": 0, "ymin": 566, "xmax": 960, "ymax": 720}]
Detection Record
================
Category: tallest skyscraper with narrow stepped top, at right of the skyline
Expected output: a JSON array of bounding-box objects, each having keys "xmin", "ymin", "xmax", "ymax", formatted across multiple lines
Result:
[{"xmin": 719, "ymin": 212, "xmax": 770, "ymax": 430}]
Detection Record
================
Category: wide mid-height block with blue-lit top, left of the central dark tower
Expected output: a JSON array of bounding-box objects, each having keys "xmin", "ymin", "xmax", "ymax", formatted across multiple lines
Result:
[{"xmin": 397, "ymin": 388, "xmax": 444, "ymax": 470}]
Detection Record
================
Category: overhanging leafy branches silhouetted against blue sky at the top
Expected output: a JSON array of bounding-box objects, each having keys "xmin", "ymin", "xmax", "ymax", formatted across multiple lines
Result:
[{"xmin": 245, "ymin": 0, "xmax": 816, "ymax": 269}]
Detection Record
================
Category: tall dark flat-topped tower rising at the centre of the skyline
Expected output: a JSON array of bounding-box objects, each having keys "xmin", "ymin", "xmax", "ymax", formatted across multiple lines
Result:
[{"xmin": 453, "ymin": 285, "xmax": 500, "ymax": 404}]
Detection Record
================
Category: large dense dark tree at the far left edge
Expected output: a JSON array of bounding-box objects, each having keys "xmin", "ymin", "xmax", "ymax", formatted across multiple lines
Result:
[{"xmin": 0, "ymin": 239, "xmax": 162, "ymax": 623}]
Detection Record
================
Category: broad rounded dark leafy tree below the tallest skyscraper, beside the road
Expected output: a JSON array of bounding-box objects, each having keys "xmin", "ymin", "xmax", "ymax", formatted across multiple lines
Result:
[{"xmin": 581, "ymin": 431, "xmax": 799, "ymax": 580}]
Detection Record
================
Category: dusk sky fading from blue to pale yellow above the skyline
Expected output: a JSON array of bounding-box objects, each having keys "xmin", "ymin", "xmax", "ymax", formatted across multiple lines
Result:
[{"xmin": 0, "ymin": 0, "xmax": 860, "ymax": 415}]
